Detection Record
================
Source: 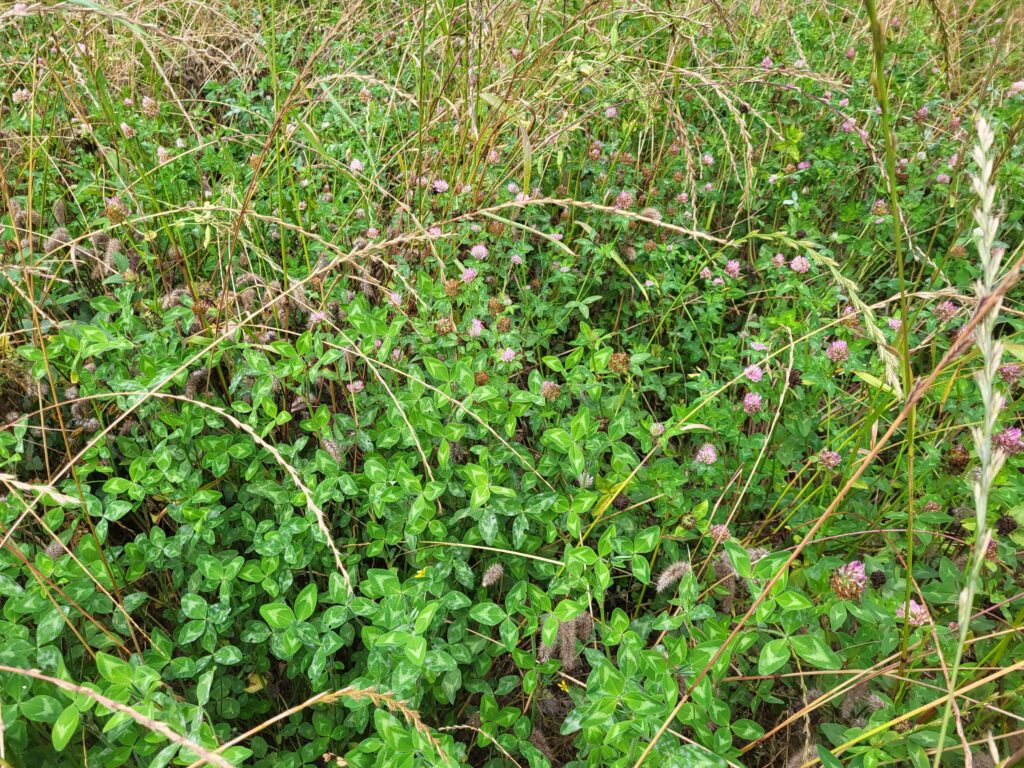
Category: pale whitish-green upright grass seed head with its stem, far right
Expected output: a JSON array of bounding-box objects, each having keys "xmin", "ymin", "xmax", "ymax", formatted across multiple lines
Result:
[{"xmin": 933, "ymin": 118, "xmax": 1007, "ymax": 768}]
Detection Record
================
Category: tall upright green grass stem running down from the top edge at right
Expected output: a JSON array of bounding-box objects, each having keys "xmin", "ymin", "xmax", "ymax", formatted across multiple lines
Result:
[{"xmin": 864, "ymin": 0, "xmax": 918, "ymax": 662}]
